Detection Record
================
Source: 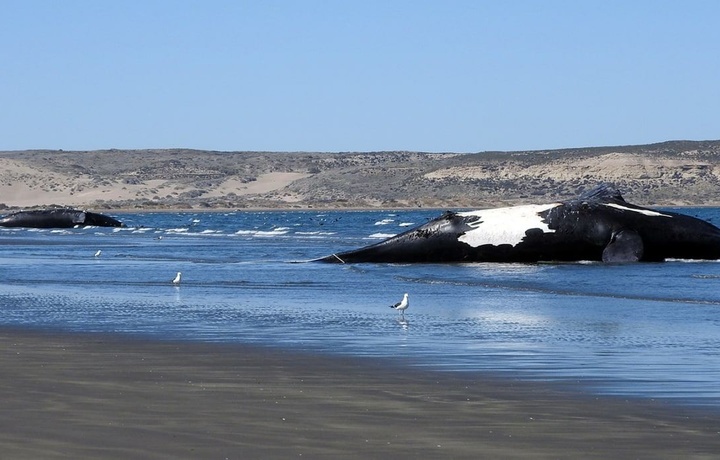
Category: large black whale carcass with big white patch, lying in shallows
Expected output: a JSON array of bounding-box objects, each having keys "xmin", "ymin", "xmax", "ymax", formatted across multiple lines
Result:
[{"xmin": 317, "ymin": 185, "xmax": 720, "ymax": 263}]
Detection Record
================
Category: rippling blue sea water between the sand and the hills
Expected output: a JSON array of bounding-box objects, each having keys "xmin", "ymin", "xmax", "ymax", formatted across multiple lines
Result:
[{"xmin": 0, "ymin": 208, "xmax": 720, "ymax": 409}]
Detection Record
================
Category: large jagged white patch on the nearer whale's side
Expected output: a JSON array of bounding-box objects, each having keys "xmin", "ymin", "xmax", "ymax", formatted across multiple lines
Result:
[{"xmin": 458, "ymin": 203, "xmax": 561, "ymax": 248}]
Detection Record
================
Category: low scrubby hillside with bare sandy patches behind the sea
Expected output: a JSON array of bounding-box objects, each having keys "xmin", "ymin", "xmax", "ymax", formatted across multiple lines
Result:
[{"xmin": 0, "ymin": 141, "xmax": 720, "ymax": 209}]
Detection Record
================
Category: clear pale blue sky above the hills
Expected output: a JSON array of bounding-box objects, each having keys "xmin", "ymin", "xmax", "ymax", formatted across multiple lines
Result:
[{"xmin": 0, "ymin": 0, "xmax": 720, "ymax": 152}]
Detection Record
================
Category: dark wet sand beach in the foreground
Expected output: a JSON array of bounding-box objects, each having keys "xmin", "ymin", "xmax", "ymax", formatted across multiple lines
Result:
[{"xmin": 0, "ymin": 328, "xmax": 720, "ymax": 459}]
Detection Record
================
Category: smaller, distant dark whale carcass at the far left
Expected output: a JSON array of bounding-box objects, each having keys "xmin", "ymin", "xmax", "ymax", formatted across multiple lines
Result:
[{"xmin": 0, "ymin": 208, "xmax": 123, "ymax": 228}]
